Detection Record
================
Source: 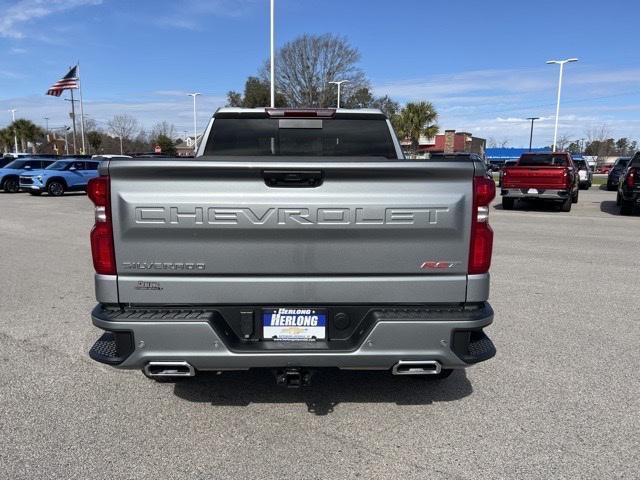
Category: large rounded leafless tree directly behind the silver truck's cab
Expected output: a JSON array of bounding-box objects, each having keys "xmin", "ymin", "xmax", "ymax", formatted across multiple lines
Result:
[{"xmin": 261, "ymin": 34, "xmax": 369, "ymax": 107}]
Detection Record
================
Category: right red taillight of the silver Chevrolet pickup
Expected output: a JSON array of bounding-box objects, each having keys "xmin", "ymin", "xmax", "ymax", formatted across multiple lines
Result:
[{"xmin": 469, "ymin": 177, "xmax": 496, "ymax": 275}]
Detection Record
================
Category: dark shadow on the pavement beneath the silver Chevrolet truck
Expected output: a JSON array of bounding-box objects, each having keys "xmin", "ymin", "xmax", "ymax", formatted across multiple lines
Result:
[{"xmin": 174, "ymin": 370, "xmax": 473, "ymax": 416}]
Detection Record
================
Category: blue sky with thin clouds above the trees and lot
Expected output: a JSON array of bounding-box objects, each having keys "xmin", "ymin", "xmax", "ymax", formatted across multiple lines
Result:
[{"xmin": 0, "ymin": 0, "xmax": 640, "ymax": 146}]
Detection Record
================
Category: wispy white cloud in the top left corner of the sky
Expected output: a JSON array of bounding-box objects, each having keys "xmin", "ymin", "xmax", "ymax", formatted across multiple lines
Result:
[{"xmin": 0, "ymin": 0, "xmax": 102, "ymax": 38}]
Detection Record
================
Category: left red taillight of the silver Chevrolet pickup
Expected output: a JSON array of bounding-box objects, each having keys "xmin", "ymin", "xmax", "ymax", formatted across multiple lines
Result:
[{"xmin": 87, "ymin": 176, "xmax": 116, "ymax": 275}]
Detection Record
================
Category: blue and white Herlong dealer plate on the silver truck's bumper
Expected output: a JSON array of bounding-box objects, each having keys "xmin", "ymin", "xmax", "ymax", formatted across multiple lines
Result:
[{"xmin": 262, "ymin": 307, "xmax": 327, "ymax": 342}]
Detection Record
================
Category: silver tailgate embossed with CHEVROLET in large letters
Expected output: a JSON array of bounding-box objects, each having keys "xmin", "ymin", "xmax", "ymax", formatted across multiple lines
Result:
[{"xmin": 109, "ymin": 159, "xmax": 476, "ymax": 304}]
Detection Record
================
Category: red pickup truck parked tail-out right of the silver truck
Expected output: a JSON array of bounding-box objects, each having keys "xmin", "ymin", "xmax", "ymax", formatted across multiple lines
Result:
[{"xmin": 500, "ymin": 152, "xmax": 580, "ymax": 212}]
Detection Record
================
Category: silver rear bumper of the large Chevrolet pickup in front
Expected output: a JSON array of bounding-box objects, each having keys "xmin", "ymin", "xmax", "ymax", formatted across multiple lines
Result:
[{"xmin": 90, "ymin": 303, "xmax": 496, "ymax": 370}]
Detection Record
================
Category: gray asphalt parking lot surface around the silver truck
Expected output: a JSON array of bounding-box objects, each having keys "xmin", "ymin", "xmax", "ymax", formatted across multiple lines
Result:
[{"xmin": 0, "ymin": 187, "xmax": 640, "ymax": 479}]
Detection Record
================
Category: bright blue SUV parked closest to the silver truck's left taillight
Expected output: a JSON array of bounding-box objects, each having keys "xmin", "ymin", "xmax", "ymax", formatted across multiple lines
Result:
[{"xmin": 20, "ymin": 158, "xmax": 100, "ymax": 197}]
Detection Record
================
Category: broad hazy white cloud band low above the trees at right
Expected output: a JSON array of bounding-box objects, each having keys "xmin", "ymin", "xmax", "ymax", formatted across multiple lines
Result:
[{"xmin": 374, "ymin": 64, "xmax": 640, "ymax": 145}]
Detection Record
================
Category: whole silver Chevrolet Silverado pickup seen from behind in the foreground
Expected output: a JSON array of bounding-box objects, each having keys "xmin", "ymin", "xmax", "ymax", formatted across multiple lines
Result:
[{"xmin": 88, "ymin": 108, "xmax": 495, "ymax": 386}]
